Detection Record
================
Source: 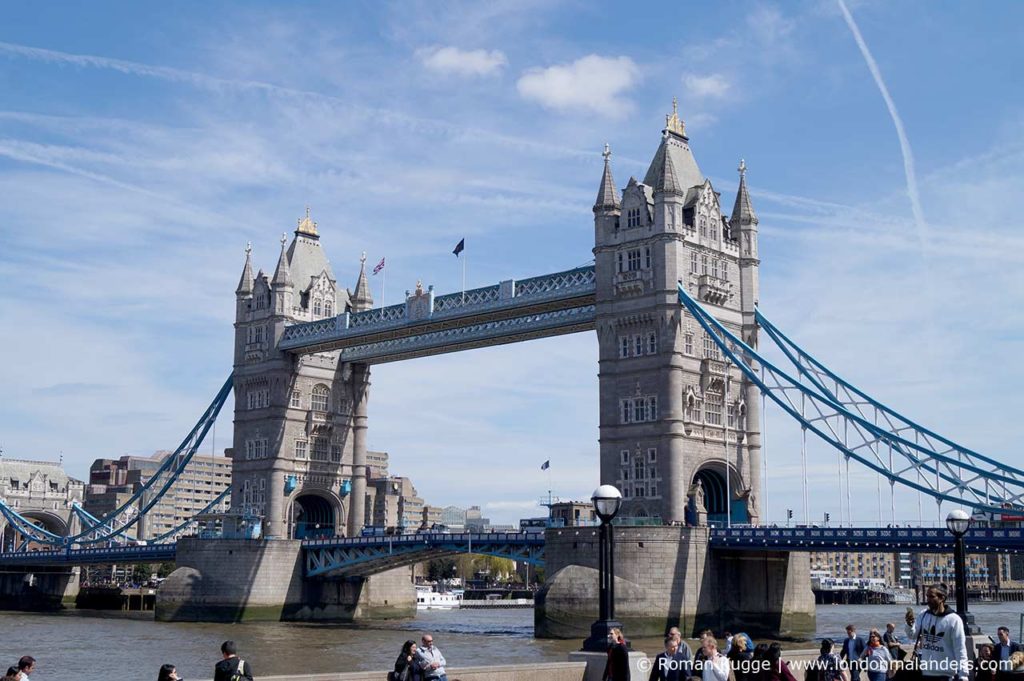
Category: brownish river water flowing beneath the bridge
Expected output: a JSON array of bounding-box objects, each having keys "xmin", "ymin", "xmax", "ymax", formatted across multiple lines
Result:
[{"xmin": 0, "ymin": 603, "xmax": 1024, "ymax": 681}]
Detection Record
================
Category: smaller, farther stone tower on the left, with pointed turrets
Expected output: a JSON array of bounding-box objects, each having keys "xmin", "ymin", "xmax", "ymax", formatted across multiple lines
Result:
[{"xmin": 231, "ymin": 209, "xmax": 373, "ymax": 539}]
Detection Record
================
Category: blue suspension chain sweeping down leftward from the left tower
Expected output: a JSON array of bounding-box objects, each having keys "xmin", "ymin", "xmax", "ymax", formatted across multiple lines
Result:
[{"xmin": 0, "ymin": 376, "xmax": 232, "ymax": 547}]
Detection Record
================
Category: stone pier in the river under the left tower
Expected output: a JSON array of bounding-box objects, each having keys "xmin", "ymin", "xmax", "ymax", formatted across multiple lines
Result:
[{"xmin": 156, "ymin": 538, "xmax": 416, "ymax": 622}]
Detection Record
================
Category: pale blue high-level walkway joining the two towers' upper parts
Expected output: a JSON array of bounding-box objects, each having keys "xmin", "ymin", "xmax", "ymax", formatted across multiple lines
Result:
[{"xmin": 279, "ymin": 265, "xmax": 596, "ymax": 364}]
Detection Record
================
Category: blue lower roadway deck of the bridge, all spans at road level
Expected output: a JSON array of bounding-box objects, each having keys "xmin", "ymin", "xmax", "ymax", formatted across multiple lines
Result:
[{"xmin": 0, "ymin": 527, "xmax": 1024, "ymax": 577}]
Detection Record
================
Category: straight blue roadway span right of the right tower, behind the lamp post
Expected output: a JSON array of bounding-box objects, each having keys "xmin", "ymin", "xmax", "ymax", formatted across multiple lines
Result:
[{"xmin": 709, "ymin": 527, "xmax": 1024, "ymax": 553}]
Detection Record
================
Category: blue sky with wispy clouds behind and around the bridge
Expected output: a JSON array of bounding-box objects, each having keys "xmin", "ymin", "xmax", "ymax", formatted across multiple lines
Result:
[{"xmin": 0, "ymin": 0, "xmax": 1024, "ymax": 521}]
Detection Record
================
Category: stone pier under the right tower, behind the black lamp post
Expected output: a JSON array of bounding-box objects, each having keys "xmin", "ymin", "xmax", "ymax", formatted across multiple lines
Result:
[{"xmin": 535, "ymin": 526, "xmax": 815, "ymax": 638}]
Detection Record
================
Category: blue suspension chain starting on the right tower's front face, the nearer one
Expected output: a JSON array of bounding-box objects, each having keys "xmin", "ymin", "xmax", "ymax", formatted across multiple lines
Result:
[{"xmin": 678, "ymin": 284, "xmax": 1024, "ymax": 511}]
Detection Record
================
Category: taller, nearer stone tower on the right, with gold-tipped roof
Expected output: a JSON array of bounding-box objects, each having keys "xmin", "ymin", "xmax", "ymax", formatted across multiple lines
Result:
[{"xmin": 594, "ymin": 102, "xmax": 761, "ymax": 523}]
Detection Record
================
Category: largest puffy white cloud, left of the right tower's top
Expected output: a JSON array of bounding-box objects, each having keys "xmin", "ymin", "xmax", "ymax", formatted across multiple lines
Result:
[{"xmin": 516, "ymin": 54, "xmax": 640, "ymax": 118}]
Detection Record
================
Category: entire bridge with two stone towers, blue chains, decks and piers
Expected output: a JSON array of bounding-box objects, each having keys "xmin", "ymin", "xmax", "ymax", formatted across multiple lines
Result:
[{"xmin": 0, "ymin": 100, "xmax": 1024, "ymax": 636}]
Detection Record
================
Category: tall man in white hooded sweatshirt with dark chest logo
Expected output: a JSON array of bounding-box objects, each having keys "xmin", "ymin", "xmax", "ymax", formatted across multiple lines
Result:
[{"xmin": 906, "ymin": 584, "xmax": 970, "ymax": 681}]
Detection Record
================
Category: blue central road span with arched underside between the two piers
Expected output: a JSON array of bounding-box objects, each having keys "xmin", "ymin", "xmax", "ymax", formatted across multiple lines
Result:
[{"xmin": 302, "ymin": 533, "xmax": 544, "ymax": 577}]
